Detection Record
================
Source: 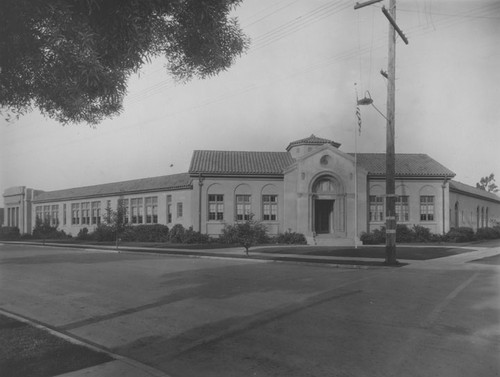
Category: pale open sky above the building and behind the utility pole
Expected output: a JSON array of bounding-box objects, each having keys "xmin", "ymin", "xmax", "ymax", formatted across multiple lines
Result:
[{"xmin": 0, "ymin": 0, "xmax": 500, "ymax": 193}]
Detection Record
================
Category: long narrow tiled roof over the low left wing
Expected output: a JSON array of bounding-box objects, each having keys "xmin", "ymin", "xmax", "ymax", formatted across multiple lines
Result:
[{"xmin": 34, "ymin": 173, "xmax": 192, "ymax": 202}]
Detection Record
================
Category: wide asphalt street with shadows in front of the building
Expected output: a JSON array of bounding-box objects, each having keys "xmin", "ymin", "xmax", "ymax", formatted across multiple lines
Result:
[{"xmin": 0, "ymin": 244, "xmax": 500, "ymax": 377}]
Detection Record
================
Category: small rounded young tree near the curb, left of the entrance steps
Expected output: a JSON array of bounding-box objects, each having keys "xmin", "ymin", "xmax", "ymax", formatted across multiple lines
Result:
[{"xmin": 222, "ymin": 214, "xmax": 267, "ymax": 256}]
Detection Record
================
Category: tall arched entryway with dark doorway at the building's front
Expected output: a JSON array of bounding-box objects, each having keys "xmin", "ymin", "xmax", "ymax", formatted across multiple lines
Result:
[{"xmin": 311, "ymin": 175, "xmax": 345, "ymax": 234}]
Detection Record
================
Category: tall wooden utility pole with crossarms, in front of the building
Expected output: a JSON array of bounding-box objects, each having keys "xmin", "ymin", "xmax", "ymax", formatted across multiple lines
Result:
[{"xmin": 354, "ymin": 0, "xmax": 408, "ymax": 265}]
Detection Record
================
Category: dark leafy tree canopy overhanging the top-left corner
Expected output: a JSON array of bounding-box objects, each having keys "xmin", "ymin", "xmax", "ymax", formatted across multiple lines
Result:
[{"xmin": 0, "ymin": 0, "xmax": 248, "ymax": 124}]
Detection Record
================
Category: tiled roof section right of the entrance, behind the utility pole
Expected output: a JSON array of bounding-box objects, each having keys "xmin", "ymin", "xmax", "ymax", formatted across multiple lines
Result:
[{"xmin": 350, "ymin": 153, "xmax": 455, "ymax": 178}]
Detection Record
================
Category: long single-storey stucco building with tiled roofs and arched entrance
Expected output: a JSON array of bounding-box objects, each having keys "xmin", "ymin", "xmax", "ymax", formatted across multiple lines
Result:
[{"xmin": 3, "ymin": 135, "xmax": 500, "ymax": 245}]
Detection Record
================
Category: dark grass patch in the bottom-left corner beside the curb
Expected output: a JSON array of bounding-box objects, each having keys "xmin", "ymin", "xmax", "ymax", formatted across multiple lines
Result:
[{"xmin": 0, "ymin": 314, "xmax": 113, "ymax": 377}]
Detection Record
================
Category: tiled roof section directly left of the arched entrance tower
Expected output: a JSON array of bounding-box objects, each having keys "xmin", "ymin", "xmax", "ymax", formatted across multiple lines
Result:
[{"xmin": 189, "ymin": 150, "xmax": 294, "ymax": 175}]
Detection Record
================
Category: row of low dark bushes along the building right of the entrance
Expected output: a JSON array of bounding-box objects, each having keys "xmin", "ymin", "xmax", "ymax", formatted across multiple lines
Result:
[{"xmin": 361, "ymin": 224, "xmax": 500, "ymax": 245}]
